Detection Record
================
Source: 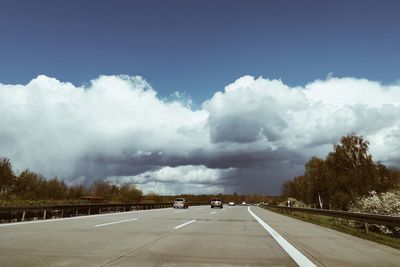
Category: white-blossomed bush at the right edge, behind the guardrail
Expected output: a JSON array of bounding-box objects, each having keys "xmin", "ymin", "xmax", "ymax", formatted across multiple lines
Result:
[{"xmin": 349, "ymin": 190, "xmax": 400, "ymax": 236}]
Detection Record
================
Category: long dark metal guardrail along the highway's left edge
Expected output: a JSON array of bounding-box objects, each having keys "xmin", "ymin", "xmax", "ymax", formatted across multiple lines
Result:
[{"xmin": 0, "ymin": 202, "xmax": 205, "ymax": 223}]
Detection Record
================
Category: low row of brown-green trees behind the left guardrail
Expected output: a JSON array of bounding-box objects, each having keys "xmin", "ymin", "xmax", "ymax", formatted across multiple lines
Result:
[{"xmin": 0, "ymin": 158, "xmax": 143, "ymax": 202}]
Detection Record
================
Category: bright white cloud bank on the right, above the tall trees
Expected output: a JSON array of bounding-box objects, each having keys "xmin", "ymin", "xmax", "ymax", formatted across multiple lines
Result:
[{"xmin": 203, "ymin": 76, "xmax": 400, "ymax": 160}]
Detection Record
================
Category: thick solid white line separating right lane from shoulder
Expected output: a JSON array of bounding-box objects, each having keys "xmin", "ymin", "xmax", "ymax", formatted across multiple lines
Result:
[{"xmin": 247, "ymin": 207, "xmax": 316, "ymax": 267}]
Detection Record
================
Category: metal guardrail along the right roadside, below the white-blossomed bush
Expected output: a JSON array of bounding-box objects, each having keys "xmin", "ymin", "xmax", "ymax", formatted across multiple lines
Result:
[{"xmin": 264, "ymin": 205, "xmax": 400, "ymax": 227}]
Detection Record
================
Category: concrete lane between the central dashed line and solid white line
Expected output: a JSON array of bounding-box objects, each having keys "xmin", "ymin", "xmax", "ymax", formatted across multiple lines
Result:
[{"xmin": 106, "ymin": 206, "xmax": 297, "ymax": 266}]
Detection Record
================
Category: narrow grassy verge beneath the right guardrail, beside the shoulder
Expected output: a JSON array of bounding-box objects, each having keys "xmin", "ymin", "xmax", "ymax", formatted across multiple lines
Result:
[{"xmin": 262, "ymin": 209, "xmax": 400, "ymax": 250}]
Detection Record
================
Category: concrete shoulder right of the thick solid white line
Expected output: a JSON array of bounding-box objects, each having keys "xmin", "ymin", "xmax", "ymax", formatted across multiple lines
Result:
[{"xmin": 251, "ymin": 207, "xmax": 400, "ymax": 266}]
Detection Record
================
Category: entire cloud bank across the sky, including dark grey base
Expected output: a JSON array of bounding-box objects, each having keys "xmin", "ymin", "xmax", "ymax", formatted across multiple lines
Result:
[{"xmin": 0, "ymin": 75, "xmax": 400, "ymax": 194}]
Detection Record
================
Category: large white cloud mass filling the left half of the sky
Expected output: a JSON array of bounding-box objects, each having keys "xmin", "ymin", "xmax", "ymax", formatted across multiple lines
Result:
[{"xmin": 0, "ymin": 76, "xmax": 208, "ymax": 180}]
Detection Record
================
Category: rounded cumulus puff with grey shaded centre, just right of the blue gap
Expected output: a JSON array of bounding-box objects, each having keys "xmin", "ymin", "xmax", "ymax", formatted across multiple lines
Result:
[{"xmin": 203, "ymin": 76, "xmax": 307, "ymax": 146}]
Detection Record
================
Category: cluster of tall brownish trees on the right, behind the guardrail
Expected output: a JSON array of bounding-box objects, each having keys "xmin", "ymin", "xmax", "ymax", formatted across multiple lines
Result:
[{"xmin": 282, "ymin": 134, "xmax": 400, "ymax": 210}]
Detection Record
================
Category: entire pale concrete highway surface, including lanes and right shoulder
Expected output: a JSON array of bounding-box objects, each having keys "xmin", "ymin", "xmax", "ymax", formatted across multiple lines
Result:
[{"xmin": 0, "ymin": 205, "xmax": 400, "ymax": 266}]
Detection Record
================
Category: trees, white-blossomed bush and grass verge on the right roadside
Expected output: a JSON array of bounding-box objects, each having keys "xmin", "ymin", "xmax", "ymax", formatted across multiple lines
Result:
[{"xmin": 278, "ymin": 134, "xmax": 400, "ymax": 241}]
